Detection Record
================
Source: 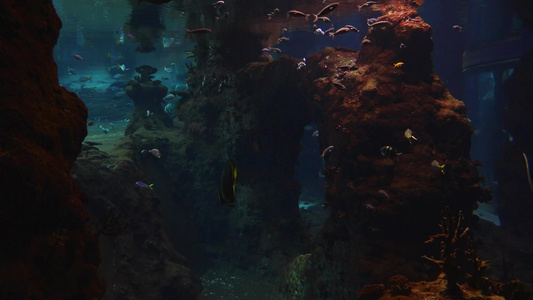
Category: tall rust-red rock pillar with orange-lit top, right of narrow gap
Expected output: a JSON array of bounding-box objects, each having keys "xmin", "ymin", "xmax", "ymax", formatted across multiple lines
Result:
[{"xmin": 285, "ymin": 10, "xmax": 490, "ymax": 299}]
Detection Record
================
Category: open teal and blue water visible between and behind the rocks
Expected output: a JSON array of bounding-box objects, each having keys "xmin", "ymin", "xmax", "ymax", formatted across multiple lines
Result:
[{"xmin": 54, "ymin": 0, "xmax": 529, "ymax": 299}]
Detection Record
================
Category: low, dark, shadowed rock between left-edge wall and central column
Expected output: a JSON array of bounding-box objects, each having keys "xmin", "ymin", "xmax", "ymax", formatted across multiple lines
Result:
[{"xmin": 72, "ymin": 144, "xmax": 202, "ymax": 300}]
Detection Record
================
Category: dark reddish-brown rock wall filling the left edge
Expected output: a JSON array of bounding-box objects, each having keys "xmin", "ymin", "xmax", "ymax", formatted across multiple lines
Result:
[{"xmin": 0, "ymin": 0, "xmax": 105, "ymax": 299}]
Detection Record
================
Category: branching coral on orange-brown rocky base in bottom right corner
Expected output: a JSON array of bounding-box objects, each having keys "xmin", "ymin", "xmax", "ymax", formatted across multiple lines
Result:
[{"xmin": 359, "ymin": 207, "xmax": 533, "ymax": 300}]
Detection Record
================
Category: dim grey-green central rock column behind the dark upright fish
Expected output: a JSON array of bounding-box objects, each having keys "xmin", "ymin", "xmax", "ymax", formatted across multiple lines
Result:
[{"xmin": 177, "ymin": 57, "xmax": 311, "ymax": 271}]
